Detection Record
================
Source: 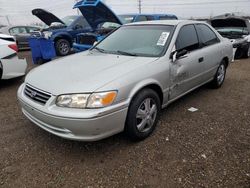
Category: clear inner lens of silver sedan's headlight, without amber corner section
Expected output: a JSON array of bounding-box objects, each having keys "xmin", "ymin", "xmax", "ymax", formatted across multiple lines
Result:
[{"xmin": 56, "ymin": 94, "xmax": 89, "ymax": 108}]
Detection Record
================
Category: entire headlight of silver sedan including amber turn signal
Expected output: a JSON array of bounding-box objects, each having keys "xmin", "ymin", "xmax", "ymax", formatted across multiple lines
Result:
[{"xmin": 56, "ymin": 91, "xmax": 117, "ymax": 109}]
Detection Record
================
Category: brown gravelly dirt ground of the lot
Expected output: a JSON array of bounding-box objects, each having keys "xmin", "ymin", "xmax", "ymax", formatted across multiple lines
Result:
[{"xmin": 0, "ymin": 52, "xmax": 250, "ymax": 188}]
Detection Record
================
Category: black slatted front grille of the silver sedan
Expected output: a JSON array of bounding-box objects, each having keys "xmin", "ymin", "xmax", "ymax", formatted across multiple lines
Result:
[{"xmin": 24, "ymin": 85, "xmax": 51, "ymax": 104}]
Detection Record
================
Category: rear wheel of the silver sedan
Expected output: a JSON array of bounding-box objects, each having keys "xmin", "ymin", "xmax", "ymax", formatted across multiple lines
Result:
[{"xmin": 210, "ymin": 60, "xmax": 227, "ymax": 89}]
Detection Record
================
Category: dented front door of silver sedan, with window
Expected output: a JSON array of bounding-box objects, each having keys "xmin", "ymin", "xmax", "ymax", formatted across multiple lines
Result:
[{"xmin": 170, "ymin": 24, "xmax": 204, "ymax": 100}]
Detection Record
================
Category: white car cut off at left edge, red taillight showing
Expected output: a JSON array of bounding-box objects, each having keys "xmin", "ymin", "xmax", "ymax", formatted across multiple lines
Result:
[{"xmin": 0, "ymin": 34, "xmax": 27, "ymax": 80}]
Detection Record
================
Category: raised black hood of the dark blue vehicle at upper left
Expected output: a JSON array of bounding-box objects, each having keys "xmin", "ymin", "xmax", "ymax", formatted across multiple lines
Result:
[{"xmin": 32, "ymin": 9, "xmax": 65, "ymax": 26}]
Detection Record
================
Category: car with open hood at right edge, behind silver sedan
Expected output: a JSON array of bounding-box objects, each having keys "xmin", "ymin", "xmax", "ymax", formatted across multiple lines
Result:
[{"xmin": 211, "ymin": 14, "xmax": 250, "ymax": 58}]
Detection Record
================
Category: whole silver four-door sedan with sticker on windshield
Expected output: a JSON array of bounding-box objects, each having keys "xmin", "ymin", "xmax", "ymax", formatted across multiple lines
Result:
[{"xmin": 18, "ymin": 20, "xmax": 233, "ymax": 141}]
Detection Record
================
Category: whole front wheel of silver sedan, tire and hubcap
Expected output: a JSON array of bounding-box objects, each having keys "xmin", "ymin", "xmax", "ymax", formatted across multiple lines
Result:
[{"xmin": 125, "ymin": 89, "xmax": 161, "ymax": 141}]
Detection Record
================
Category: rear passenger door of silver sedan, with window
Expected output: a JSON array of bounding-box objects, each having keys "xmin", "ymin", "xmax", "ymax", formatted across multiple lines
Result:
[{"xmin": 195, "ymin": 24, "xmax": 223, "ymax": 80}]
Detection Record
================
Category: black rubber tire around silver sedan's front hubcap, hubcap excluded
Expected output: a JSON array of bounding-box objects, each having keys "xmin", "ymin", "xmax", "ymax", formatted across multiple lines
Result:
[{"xmin": 125, "ymin": 89, "xmax": 161, "ymax": 141}]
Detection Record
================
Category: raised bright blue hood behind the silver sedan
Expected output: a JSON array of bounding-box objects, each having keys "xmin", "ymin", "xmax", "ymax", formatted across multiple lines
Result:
[{"xmin": 74, "ymin": 0, "xmax": 122, "ymax": 29}]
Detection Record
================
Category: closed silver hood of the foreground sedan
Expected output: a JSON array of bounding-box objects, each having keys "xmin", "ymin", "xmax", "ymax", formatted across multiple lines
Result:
[{"xmin": 25, "ymin": 51, "xmax": 157, "ymax": 95}]
